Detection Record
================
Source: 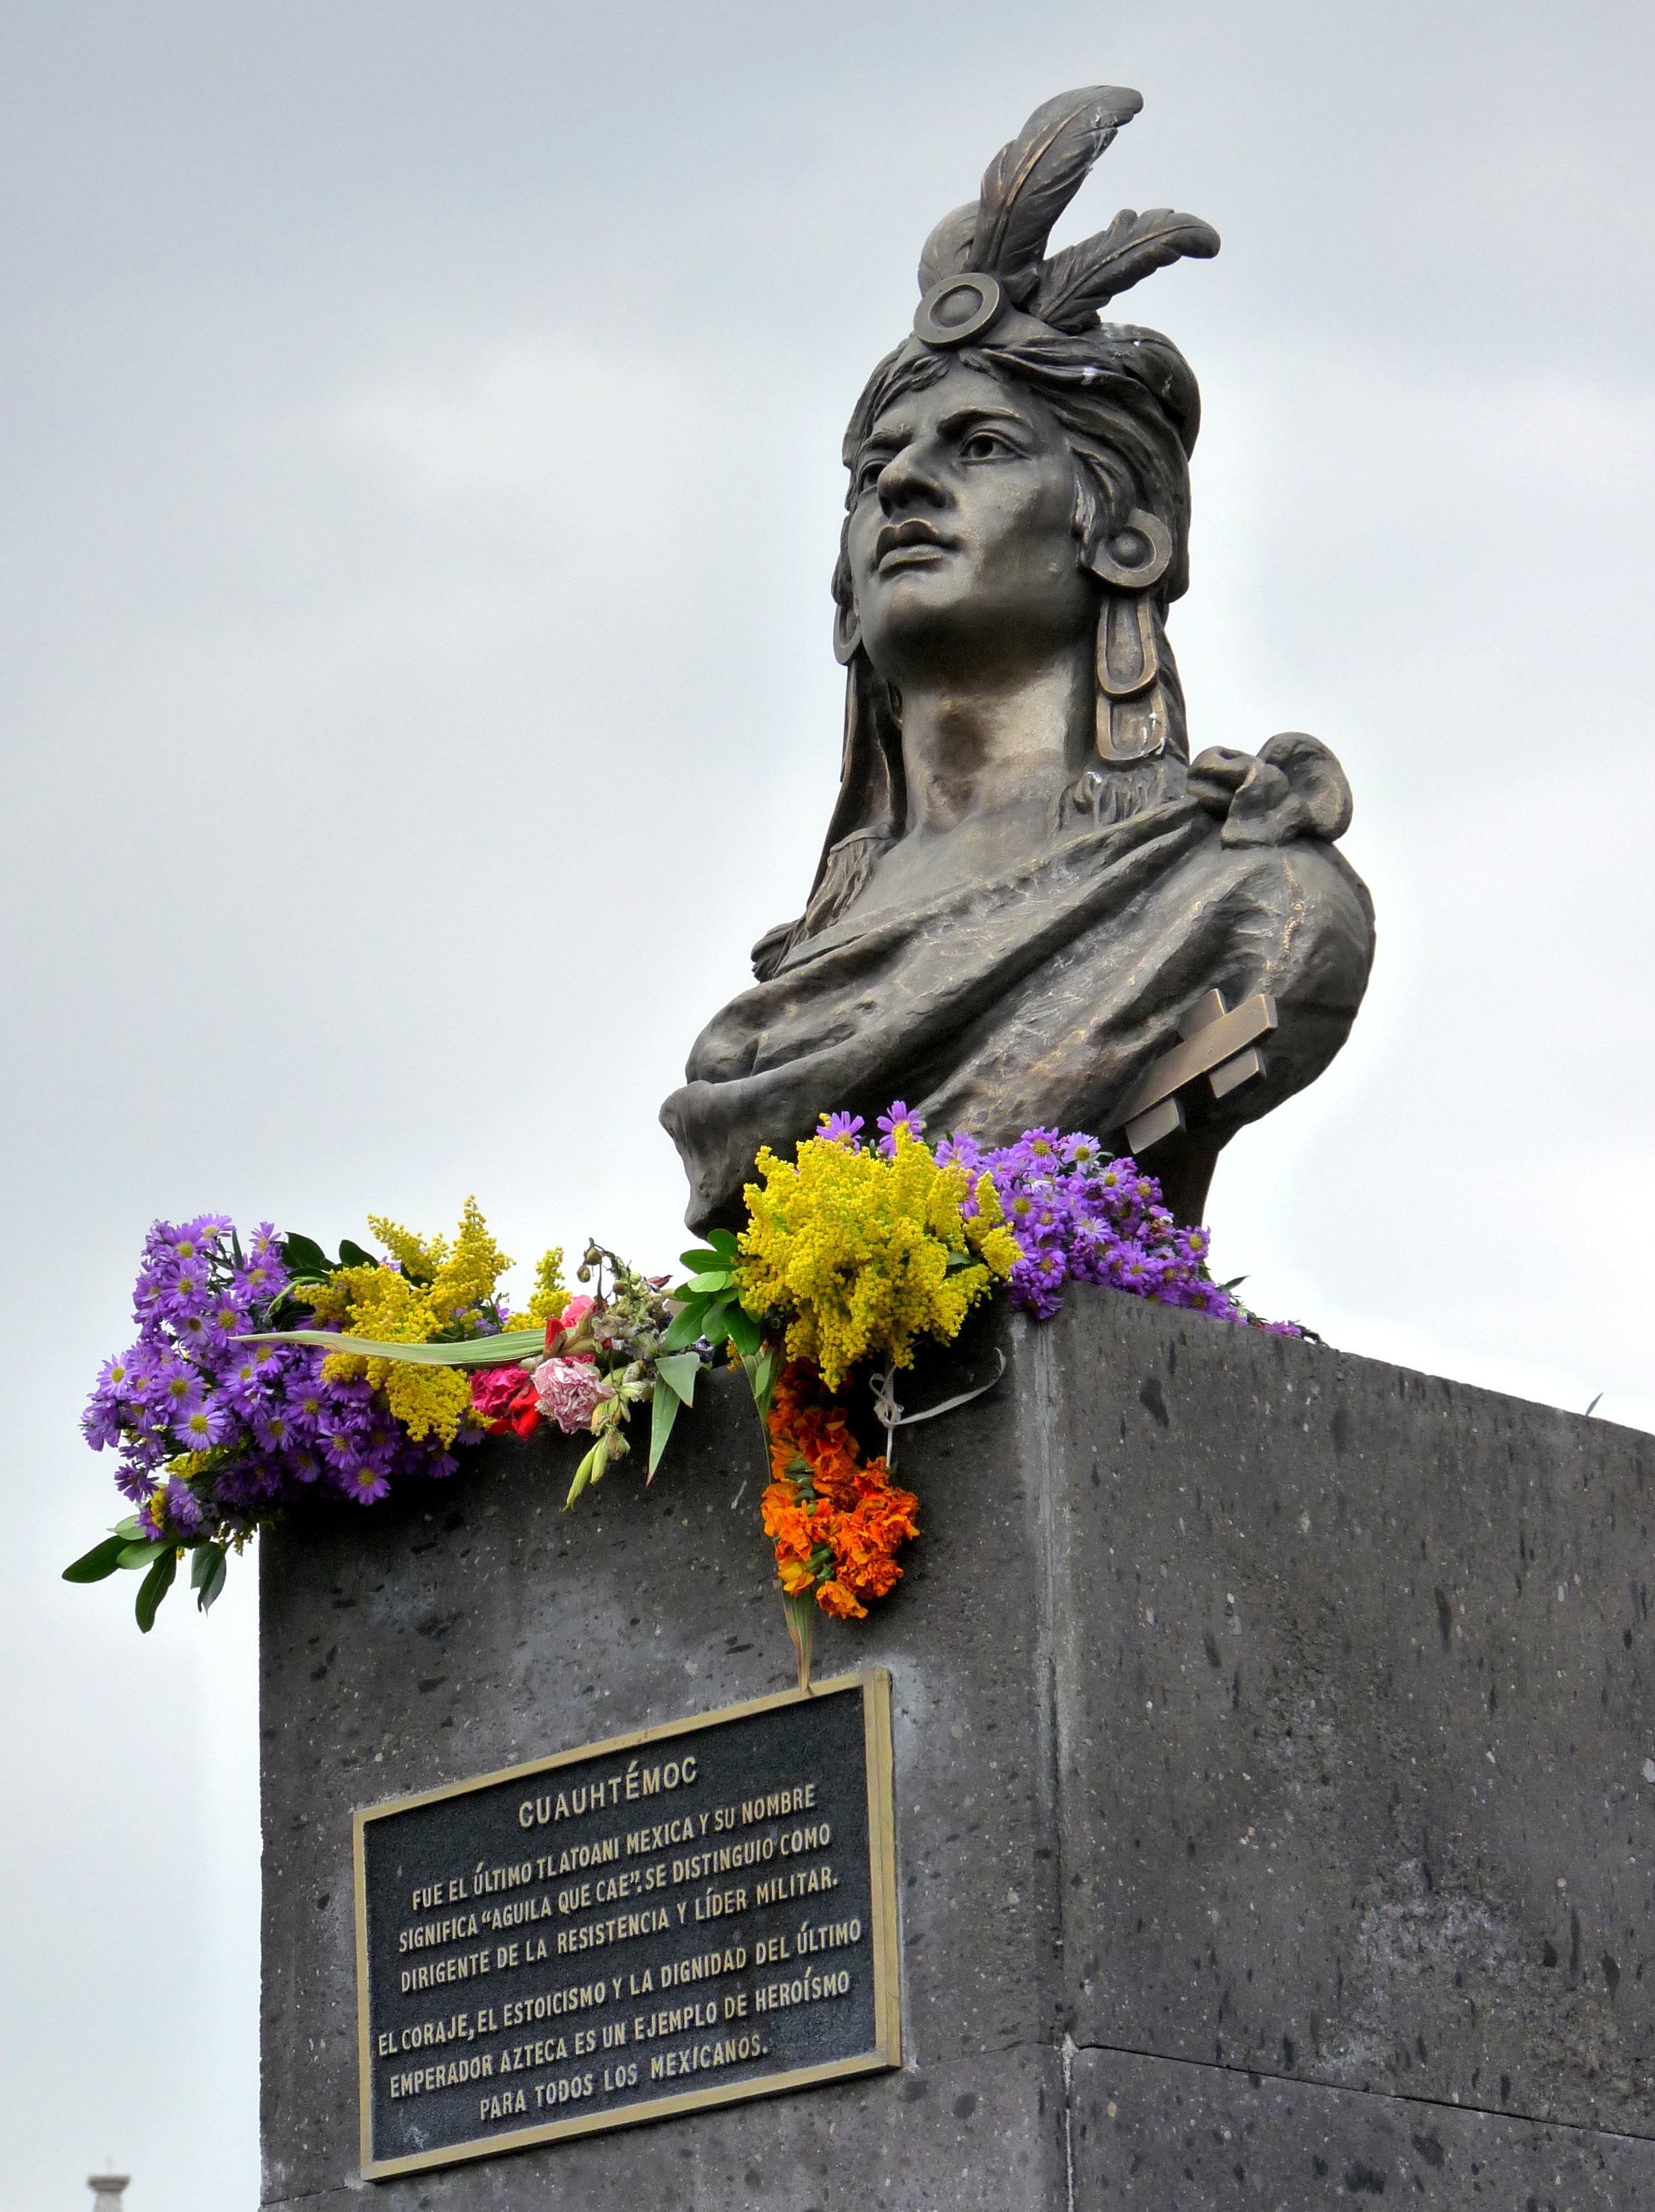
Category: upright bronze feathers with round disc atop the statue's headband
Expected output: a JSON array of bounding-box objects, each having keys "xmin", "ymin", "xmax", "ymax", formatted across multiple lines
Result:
[{"xmin": 914, "ymin": 84, "xmax": 1219, "ymax": 345}]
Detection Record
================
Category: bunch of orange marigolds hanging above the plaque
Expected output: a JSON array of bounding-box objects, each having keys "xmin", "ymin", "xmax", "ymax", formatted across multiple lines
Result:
[{"xmin": 763, "ymin": 1360, "xmax": 921, "ymax": 1681}]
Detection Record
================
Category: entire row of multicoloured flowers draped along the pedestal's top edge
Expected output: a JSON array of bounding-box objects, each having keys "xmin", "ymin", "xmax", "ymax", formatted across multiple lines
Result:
[{"xmin": 64, "ymin": 1100, "xmax": 1301, "ymax": 1681}]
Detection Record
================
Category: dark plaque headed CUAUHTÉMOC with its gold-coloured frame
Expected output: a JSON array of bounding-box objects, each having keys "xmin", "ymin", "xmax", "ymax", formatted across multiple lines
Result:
[{"xmin": 345, "ymin": 1670, "xmax": 900, "ymax": 2179}]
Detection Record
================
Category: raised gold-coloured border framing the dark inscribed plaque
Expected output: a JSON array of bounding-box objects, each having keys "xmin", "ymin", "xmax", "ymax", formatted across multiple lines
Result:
[{"xmin": 352, "ymin": 1668, "xmax": 902, "ymax": 2181}]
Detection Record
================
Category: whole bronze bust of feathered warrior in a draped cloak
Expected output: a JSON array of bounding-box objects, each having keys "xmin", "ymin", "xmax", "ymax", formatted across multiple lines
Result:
[{"xmin": 661, "ymin": 86, "xmax": 1374, "ymax": 1230}]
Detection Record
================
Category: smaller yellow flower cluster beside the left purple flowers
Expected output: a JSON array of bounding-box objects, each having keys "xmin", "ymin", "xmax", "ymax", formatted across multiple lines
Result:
[{"xmin": 294, "ymin": 1199, "xmax": 568, "ymax": 1445}]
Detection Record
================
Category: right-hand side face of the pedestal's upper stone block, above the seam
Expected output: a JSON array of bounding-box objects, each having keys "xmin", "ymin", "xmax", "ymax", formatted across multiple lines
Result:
[{"xmin": 1033, "ymin": 1316, "xmax": 1655, "ymax": 2132}]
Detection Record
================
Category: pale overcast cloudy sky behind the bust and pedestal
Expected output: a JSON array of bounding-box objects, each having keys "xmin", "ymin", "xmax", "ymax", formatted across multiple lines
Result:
[{"xmin": 0, "ymin": 0, "xmax": 1655, "ymax": 2212}]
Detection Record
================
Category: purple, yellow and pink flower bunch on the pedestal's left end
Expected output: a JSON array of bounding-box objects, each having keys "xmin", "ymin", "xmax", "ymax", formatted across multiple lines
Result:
[{"xmin": 66, "ymin": 1199, "xmax": 668, "ymax": 1630}]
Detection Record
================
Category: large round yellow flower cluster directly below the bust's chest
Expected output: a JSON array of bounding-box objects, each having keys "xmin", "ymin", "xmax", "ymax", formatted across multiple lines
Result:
[{"xmin": 739, "ymin": 1131, "xmax": 1020, "ymax": 1391}]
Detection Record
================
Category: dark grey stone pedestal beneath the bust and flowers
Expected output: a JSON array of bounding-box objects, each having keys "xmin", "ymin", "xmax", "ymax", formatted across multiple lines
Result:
[{"xmin": 261, "ymin": 1292, "xmax": 1655, "ymax": 2212}]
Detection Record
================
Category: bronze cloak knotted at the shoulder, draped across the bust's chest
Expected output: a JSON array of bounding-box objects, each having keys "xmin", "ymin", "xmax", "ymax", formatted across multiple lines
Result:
[{"xmin": 661, "ymin": 736, "xmax": 1374, "ymax": 1230}]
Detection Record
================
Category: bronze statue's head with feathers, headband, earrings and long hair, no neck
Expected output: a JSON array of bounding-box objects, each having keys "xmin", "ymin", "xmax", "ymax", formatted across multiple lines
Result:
[{"xmin": 761, "ymin": 86, "xmax": 1219, "ymax": 967}]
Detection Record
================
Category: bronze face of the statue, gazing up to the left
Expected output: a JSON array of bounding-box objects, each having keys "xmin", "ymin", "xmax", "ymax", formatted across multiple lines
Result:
[{"xmin": 848, "ymin": 360, "xmax": 1097, "ymax": 686}]
